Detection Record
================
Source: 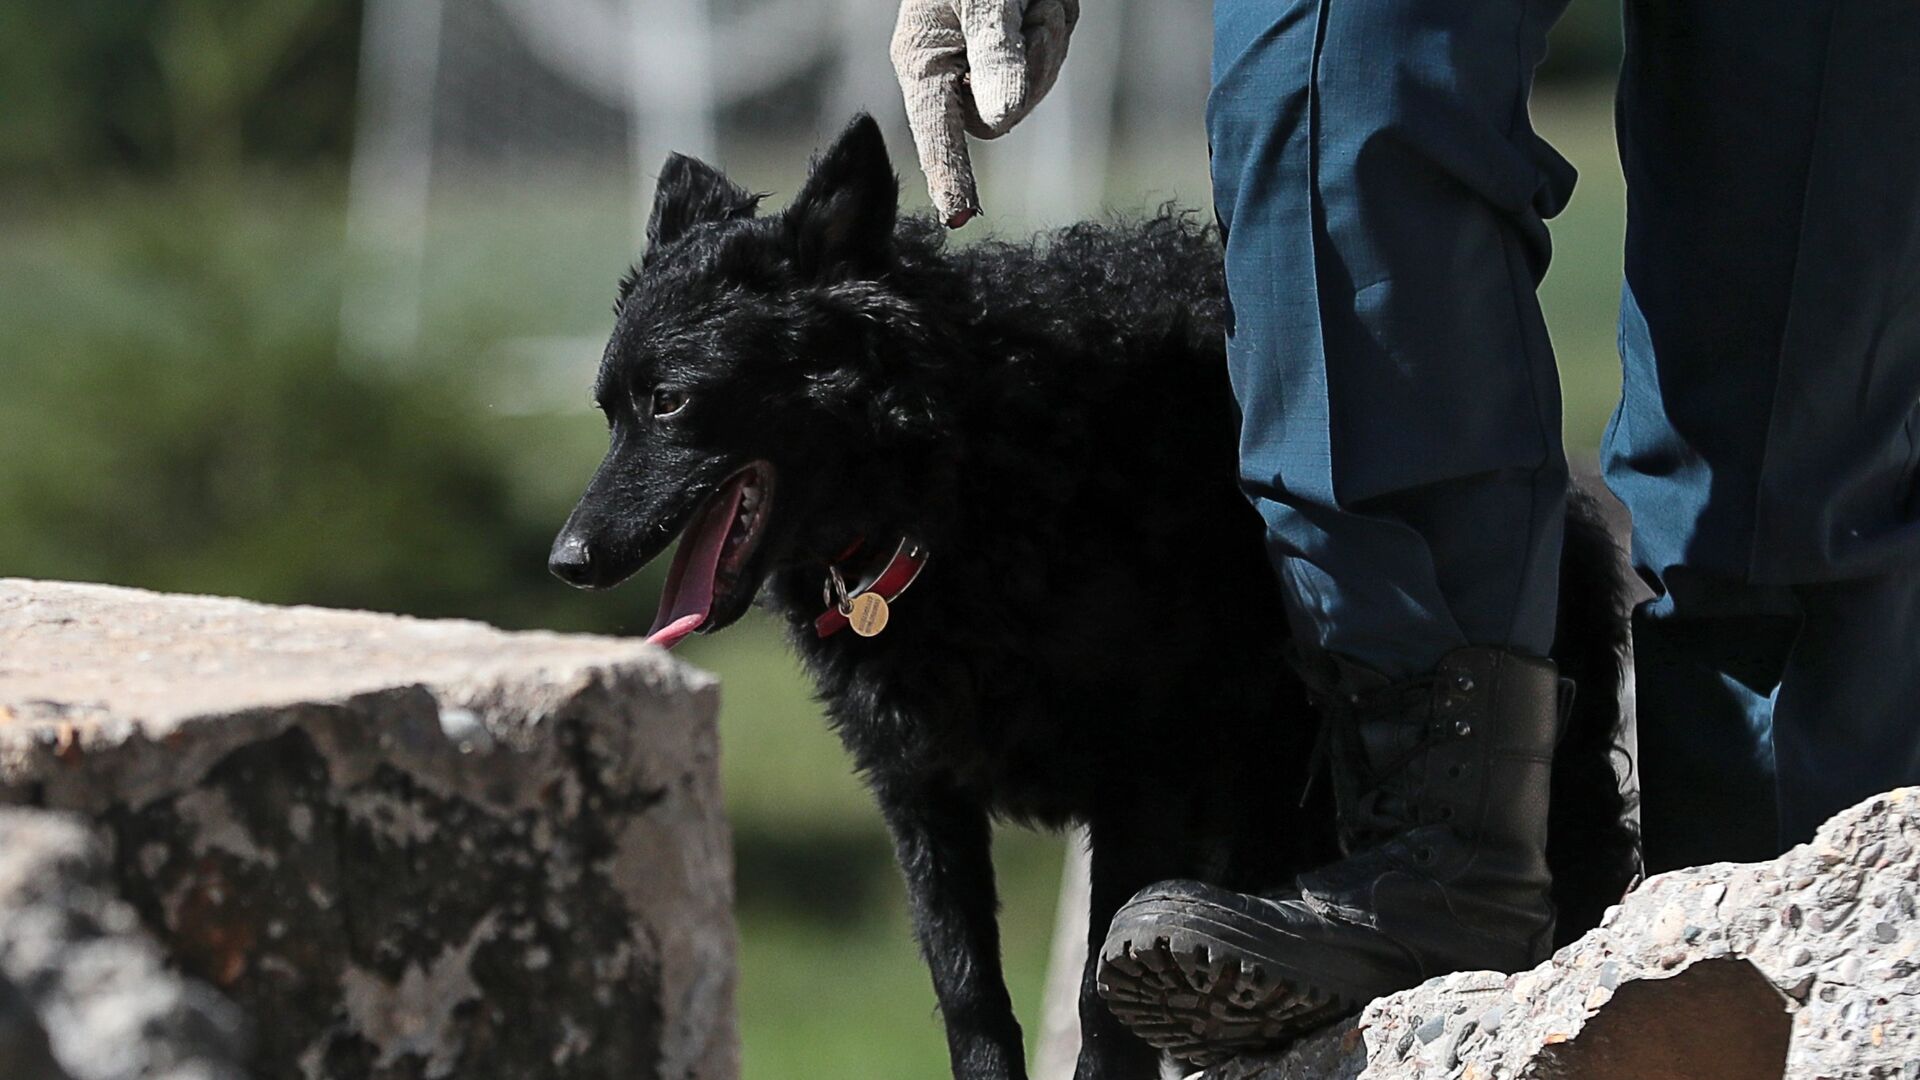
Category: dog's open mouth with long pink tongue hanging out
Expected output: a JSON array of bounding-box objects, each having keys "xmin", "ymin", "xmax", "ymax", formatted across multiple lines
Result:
[{"xmin": 647, "ymin": 461, "xmax": 774, "ymax": 648}]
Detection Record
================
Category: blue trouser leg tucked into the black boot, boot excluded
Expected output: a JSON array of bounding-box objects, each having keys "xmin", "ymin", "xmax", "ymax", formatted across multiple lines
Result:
[{"xmin": 1208, "ymin": 0, "xmax": 1572, "ymax": 678}]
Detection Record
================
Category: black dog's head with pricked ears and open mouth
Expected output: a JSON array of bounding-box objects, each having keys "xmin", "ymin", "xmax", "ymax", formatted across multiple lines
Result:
[{"xmin": 547, "ymin": 115, "xmax": 940, "ymax": 644}]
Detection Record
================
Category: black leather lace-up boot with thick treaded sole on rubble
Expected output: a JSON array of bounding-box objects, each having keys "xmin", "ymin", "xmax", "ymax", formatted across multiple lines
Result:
[{"xmin": 1098, "ymin": 648, "xmax": 1563, "ymax": 1065}]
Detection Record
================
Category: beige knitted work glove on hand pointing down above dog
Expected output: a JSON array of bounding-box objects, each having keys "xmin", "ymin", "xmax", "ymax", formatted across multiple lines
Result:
[{"xmin": 893, "ymin": 0, "xmax": 1079, "ymax": 229}]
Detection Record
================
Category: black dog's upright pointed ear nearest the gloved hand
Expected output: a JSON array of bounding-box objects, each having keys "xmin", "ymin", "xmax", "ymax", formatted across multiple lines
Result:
[{"xmin": 787, "ymin": 113, "xmax": 900, "ymax": 277}]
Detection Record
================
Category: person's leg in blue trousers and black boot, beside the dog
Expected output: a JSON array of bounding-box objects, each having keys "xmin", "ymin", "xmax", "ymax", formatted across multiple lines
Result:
[{"xmin": 1098, "ymin": 0, "xmax": 1572, "ymax": 1059}]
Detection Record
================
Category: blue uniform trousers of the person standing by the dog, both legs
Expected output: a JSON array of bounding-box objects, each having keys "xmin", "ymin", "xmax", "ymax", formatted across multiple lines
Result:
[{"xmin": 1208, "ymin": 0, "xmax": 1920, "ymax": 869}]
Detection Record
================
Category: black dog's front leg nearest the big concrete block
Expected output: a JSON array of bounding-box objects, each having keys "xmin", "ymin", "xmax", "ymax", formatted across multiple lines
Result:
[{"xmin": 879, "ymin": 784, "xmax": 1027, "ymax": 1080}]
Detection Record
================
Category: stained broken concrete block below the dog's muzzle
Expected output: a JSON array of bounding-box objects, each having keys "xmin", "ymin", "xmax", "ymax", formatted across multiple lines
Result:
[{"xmin": 0, "ymin": 580, "xmax": 737, "ymax": 1080}]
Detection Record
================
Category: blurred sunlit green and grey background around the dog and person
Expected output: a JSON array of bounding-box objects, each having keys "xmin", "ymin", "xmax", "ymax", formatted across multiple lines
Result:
[{"xmin": 0, "ymin": 0, "xmax": 1622, "ymax": 1080}]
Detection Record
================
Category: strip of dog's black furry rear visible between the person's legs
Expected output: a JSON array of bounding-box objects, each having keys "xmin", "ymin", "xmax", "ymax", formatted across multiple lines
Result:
[{"xmin": 1548, "ymin": 486, "xmax": 1640, "ymax": 947}]
